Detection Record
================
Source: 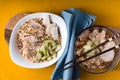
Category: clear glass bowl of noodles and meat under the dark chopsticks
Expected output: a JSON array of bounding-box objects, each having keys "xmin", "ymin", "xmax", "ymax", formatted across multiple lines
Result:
[{"xmin": 74, "ymin": 26, "xmax": 120, "ymax": 74}]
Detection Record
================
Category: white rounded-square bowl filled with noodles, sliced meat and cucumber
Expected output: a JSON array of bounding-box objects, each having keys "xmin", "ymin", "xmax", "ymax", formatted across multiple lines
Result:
[{"xmin": 10, "ymin": 13, "xmax": 67, "ymax": 68}]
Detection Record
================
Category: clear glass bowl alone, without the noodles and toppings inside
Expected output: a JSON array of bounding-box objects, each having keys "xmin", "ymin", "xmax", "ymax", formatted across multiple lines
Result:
[{"xmin": 75, "ymin": 25, "xmax": 120, "ymax": 74}]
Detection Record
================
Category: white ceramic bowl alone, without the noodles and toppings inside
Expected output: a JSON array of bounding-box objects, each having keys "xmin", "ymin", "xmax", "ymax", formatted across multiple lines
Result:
[{"xmin": 9, "ymin": 13, "xmax": 67, "ymax": 68}]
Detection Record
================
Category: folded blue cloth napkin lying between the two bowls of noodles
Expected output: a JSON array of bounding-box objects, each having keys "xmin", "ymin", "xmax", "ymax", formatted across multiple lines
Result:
[{"xmin": 51, "ymin": 8, "xmax": 96, "ymax": 80}]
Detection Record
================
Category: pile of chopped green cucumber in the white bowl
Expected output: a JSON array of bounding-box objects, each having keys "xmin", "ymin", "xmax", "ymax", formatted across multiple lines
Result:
[{"xmin": 36, "ymin": 39, "xmax": 61, "ymax": 61}]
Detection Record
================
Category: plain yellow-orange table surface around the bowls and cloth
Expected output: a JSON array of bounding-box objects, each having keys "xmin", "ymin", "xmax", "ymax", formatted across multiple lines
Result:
[{"xmin": 0, "ymin": 0, "xmax": 120, "ymax": 80}]
